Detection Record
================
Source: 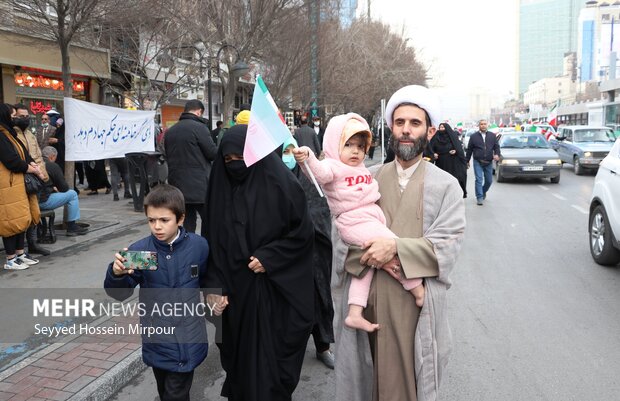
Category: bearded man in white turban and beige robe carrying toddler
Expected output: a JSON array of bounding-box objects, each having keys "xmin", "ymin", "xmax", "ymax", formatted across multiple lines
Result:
[{"xmin": 332, "ymin": 85, "xmax": 465, "ymax": 401}]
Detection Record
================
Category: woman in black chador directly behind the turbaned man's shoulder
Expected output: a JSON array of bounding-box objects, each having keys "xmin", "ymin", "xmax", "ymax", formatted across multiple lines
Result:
[{"xmin": 429, "ymin": 123, "xmax": 467, "ymax": 198}]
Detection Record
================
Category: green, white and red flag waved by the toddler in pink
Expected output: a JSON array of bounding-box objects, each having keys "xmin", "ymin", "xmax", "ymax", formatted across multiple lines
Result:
[{"xmin": 243, "ymin": 75, "xmax": 291, "ymax": 167}]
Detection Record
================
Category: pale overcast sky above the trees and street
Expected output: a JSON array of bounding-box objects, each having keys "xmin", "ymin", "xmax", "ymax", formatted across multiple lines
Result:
[{"xmin": 358, "ymin": 0, "xmax": 518, "ymax": 119}]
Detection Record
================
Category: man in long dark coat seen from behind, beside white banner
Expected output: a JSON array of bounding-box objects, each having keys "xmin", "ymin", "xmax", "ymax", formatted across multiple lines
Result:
[{"xmin": 164, "ymin": 100, "xmax": 217, "ymax": 233}]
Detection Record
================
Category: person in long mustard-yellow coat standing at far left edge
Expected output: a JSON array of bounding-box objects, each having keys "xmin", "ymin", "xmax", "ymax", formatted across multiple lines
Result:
[{"xmin": 0, "ymin": 103, "xmax": 43, "ymax": 270}]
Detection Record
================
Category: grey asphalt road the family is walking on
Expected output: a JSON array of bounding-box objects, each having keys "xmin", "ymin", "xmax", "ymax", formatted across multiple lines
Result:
[{"xmin": 0, "ymin": 165, "xmax": 620, "ymax": 401}]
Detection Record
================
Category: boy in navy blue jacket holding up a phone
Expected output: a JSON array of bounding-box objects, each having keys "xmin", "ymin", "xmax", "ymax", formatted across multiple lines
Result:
[{"xmin": 104, "ymin": 184, "xmax": 212, "ymax": 401}]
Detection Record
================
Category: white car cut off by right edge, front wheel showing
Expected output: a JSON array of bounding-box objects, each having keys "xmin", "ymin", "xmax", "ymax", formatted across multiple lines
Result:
[{"xmin": 588, "ymin": 139, "xmax": 620, "ymax": 266}]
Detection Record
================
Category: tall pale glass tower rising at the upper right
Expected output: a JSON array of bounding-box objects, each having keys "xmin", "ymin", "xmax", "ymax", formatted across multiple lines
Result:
[{"xmin": 518, "ymin": 0, "xmax": 586, "ymax": 94}]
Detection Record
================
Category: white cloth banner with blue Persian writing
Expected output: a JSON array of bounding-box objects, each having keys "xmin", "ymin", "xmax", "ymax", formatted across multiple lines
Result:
[{"xmin": 64, "ymin": 98, "xmax": 155, "ymax": 161}]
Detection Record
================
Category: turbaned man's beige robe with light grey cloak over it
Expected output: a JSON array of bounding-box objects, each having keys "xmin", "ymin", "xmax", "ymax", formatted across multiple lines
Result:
[{"xmin": 332, "ymin": 162, "xmax": 465, "ymax": 401}]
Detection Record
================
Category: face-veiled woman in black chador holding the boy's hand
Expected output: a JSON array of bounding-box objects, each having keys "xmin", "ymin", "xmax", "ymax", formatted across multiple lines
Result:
[{"xmin": 202, "ymin": 125, "xmax": 314, "ymax": 401}]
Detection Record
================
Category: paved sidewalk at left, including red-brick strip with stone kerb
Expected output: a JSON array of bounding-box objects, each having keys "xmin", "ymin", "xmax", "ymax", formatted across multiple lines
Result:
[{"xmin": 0, "ymin": 190, "xmax": 145, "ymax": 401}]
